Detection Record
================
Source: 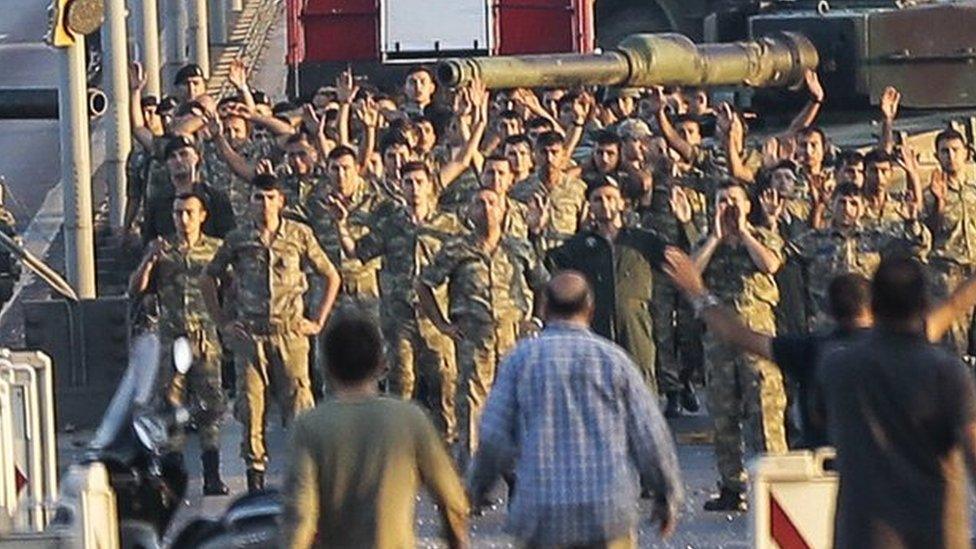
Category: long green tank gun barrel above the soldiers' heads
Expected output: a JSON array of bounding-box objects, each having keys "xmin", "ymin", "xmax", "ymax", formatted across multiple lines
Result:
[{"xmin": 436, "ymin": 32, "xmax": 819, "ymax": 89}]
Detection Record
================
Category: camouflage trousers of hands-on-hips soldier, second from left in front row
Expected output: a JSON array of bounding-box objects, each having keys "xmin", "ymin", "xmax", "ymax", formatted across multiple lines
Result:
[{"xmin": 229, "ymin": 331, "xmax": 315, "ymax": 471}]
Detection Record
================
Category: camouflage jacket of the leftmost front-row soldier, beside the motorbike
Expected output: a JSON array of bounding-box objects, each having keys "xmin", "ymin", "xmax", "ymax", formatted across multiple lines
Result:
[{"xmin": 152, "ymin": 234, "xmax": 223, "ymax": 337}]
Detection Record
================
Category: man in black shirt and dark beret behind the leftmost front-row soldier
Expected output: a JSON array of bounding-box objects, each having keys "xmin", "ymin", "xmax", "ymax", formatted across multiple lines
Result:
[{"xmin": 142, "ymin": 135, "xmax": 235, "ymax": 243}]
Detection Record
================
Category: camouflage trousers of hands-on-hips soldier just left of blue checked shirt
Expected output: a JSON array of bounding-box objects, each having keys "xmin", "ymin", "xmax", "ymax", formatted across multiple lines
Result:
[{"xmin": 454, "ymin": 319, "xmax": 518, "ymax": 470}]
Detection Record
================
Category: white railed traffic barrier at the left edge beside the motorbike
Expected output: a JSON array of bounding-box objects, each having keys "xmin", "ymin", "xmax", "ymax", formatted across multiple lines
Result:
[{"xmin": 0, "ymin": 349, "xmax": 58, "ymax": 532}]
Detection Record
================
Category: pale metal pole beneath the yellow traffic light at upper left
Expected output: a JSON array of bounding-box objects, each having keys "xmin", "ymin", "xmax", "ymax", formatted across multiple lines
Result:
[{"xmin": 58, "ymin": 35, "xmax": 95, "ymax": 299}]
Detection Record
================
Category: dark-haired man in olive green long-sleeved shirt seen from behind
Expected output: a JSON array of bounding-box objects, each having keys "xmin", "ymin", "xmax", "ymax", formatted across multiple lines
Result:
[{"xmin": 281, "ymin": 315, "xmax": 470, "ymax": 549}]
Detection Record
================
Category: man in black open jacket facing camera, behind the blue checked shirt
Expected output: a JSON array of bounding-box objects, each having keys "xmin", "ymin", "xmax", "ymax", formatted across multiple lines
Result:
[{"xmin": 547, "ymin": 176, "xmax": 666, "ymax": 394}]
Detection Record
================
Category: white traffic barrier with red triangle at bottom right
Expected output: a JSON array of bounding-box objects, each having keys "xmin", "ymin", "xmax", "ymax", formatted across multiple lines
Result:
[{"xmin": 750, "ymin": 448, "xmax": 838, "ymax": 549}]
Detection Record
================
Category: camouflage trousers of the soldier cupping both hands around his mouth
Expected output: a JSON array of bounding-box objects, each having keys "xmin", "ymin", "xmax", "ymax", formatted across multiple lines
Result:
[{"xmin": 705, "ymin": 310, "xmax": 787, "ymax": 491}]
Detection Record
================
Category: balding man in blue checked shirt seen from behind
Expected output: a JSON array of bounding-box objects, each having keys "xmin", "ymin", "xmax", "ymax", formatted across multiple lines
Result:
[{"xmin": 468, "ymin": 271, "xmax": 683, "ymax": 548}]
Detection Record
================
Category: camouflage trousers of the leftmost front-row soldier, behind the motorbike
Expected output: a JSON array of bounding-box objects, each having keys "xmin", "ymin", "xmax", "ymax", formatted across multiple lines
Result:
[{"xmin": 157, "ymin": 329, "xmax": 227, "ymax": 452}]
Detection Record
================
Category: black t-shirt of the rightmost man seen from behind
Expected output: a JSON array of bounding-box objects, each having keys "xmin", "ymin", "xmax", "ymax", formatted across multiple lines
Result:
[{"xmin": 817, "ymin": 328, "xmax": 976, "ymax": 549}]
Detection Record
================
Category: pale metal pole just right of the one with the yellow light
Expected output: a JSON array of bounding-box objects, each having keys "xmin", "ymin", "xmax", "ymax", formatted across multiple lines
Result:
[{"xmin": 102, "ymin": 0, "xmax": 132, "ymax": 229}]
